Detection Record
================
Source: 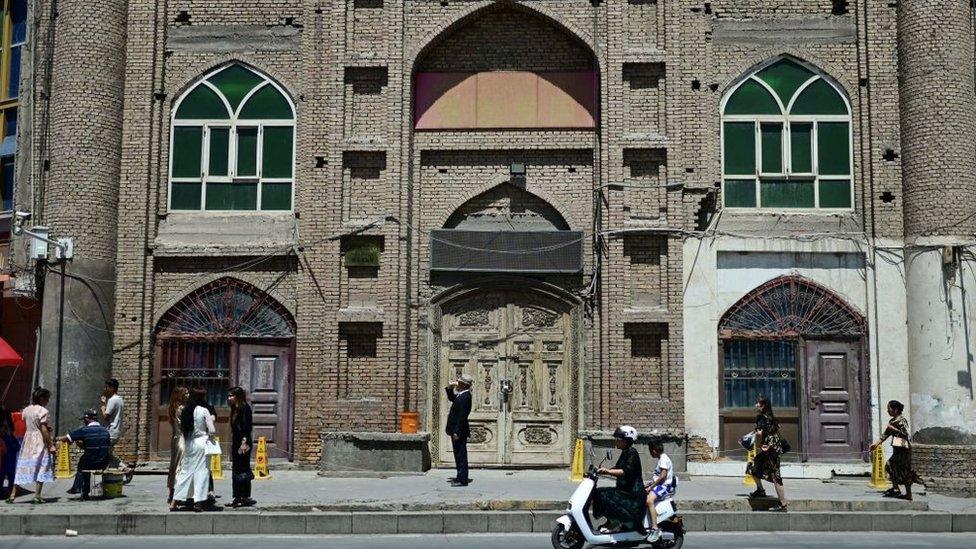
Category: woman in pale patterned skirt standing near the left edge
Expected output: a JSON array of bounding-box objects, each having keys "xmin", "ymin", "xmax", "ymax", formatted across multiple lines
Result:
[{"xmin": 7, "ymin": 387, "xmax": 56, "ymax": 503}]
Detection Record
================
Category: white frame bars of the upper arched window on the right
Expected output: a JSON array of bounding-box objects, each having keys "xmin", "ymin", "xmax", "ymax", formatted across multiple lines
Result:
[{"xmin": 719, "ymin": 57, "xmax": 854, "ymax": 213}]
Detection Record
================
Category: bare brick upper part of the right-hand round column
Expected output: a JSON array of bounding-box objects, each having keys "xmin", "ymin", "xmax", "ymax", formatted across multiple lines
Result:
[{"xmin": 898, "ymin": 0, "xmax": 976, "ymax": 235}]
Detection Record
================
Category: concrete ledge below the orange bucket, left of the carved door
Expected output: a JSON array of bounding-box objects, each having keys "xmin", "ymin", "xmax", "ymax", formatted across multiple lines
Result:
[{"xmin": 319, "ymin": 431, "xmax": 430, "ymax": 476}]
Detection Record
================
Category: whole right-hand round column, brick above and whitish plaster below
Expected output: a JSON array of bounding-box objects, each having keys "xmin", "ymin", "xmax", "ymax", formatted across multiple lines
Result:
[{"xmin": 900, "ymin": 0, "xmax": 976, "ymax": 444}]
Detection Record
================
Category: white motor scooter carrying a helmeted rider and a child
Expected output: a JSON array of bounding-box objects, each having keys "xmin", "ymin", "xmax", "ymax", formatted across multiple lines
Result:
[{"xmin": 552, "ymin": 451, "xmax": 685, "ymax": 549}]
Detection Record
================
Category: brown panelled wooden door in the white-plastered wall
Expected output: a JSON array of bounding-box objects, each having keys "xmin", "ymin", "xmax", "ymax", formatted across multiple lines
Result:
[{"xmin": 798, "ymin": 341, "xmax": 865, "ymax": 461}]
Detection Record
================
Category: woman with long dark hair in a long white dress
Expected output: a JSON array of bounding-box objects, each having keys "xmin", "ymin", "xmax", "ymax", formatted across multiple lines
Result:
[{"xmin": 172, "ymin": 388, "xmax": 217, "ymax": 513}]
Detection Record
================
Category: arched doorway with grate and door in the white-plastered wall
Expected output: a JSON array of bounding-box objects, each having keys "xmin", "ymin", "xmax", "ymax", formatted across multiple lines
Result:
[{"xmin": 718, "ymin": 276, "xmax": 870, "ymax": 461}]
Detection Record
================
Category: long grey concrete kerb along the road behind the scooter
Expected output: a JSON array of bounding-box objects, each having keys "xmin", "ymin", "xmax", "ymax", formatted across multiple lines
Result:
[{"xmin": 0, "ymin": 510, "xmax": 976, "ymax": 539}]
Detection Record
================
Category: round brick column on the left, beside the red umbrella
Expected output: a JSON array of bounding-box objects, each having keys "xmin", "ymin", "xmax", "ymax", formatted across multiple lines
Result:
[{"xmin": 35, "ymin": 0, "xmax": 127, "ymax": 431}]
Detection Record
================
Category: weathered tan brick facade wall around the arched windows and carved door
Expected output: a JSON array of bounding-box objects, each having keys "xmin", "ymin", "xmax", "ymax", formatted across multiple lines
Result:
[{"xmin": 24, "ymin": 0, "xmax": 916, "ymax": 461}]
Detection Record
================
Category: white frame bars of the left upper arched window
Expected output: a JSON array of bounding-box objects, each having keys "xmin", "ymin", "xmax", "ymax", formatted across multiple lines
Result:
[{"xmin": 166, "ymin": 63, "xmax": 298, "ymax": 213}]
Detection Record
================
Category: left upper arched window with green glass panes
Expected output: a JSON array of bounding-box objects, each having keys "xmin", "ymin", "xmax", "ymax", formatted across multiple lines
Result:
[{"xmin": 169, "ymin": 63, "xmax": 295, "ymax": 211}]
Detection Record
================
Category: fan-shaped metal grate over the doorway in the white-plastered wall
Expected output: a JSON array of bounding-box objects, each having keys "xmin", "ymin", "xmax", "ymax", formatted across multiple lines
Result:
[{"xmin": 719, "ymin": 276, "xmax": 865, "ymax": 338}]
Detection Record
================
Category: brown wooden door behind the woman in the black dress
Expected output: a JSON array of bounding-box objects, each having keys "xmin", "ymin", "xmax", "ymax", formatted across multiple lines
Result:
[{"xmin": 237, "ymin": 344, "xmax": 292, "ymax": 458}]
